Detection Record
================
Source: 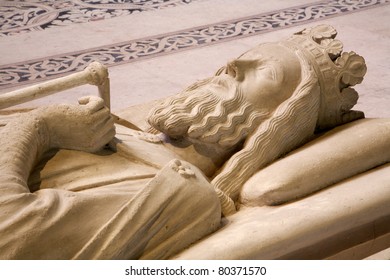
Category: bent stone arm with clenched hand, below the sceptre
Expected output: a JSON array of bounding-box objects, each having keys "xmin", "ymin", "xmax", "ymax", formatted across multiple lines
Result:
[{"xmin": 0, "ymin": 97, "xmax": 115, "ymax": 195}]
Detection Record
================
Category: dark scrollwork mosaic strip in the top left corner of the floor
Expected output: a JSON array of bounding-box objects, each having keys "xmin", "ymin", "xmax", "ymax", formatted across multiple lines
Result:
[{"xmin": 0, "ymin": 0, "xmax": 196, "ymax": 37}]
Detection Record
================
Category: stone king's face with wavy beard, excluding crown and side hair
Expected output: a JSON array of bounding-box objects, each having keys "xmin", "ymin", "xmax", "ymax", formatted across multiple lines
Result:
[{"xmin": 149, "ymin": 41, "xmax": 310, "ymax": 148}]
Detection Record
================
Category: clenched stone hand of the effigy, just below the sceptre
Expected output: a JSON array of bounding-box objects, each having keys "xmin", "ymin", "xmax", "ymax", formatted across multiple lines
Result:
[{"xmin": 42, "ymin": 96, "xmax": 115, "ymax": 152}]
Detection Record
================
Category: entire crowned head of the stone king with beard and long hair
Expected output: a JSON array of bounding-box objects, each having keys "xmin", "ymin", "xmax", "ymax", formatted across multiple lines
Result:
[{"xmin": 149, "ymin": 25, "xmax": 366, "ymax": 217}]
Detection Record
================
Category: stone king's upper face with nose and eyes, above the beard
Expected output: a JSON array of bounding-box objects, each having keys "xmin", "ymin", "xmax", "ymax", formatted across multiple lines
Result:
[{"xmin": 213, "ymin": 43, "xmax": 301, "ymax": 115}]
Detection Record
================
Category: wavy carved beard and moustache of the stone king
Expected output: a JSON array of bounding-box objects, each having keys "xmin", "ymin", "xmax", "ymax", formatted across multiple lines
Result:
[{"xmin": 148, "ymin": 76, "xmax": 267, "ymax": 147}]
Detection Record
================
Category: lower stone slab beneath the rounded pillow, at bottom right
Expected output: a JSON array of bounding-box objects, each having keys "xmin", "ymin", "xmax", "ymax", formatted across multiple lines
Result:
[{"xmin": 175, "ymin": 165, "xmax": 390, "ymax": 259}]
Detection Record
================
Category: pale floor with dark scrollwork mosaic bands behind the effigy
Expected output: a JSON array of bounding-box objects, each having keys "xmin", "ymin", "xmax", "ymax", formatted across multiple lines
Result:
[{"xmin": 0, "ymin": 0, "xmax": 390, "ymax": 117}]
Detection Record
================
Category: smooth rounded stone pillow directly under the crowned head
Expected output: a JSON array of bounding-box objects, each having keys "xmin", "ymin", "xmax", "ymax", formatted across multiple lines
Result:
[{"xmin": 240, "ymin": 119, "xmax": 390, "ymax": 206}]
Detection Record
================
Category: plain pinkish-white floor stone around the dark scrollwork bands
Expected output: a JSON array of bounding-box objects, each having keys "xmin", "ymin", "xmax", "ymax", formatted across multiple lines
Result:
[{"xmin": 0, "ymin": 0, "xmax": 390, "ymax": 117}]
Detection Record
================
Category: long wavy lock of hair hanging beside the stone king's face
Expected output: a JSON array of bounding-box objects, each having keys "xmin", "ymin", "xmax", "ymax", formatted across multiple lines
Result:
[{"xmin": 212, "ymin": 50, "xmax": 320, "ymax": 216}]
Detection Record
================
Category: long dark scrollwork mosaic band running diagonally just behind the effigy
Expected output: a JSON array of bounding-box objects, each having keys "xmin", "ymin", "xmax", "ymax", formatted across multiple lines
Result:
[{"xmin": 0, "ymin": 0, "xmax": 390, "ymax": 89}]
